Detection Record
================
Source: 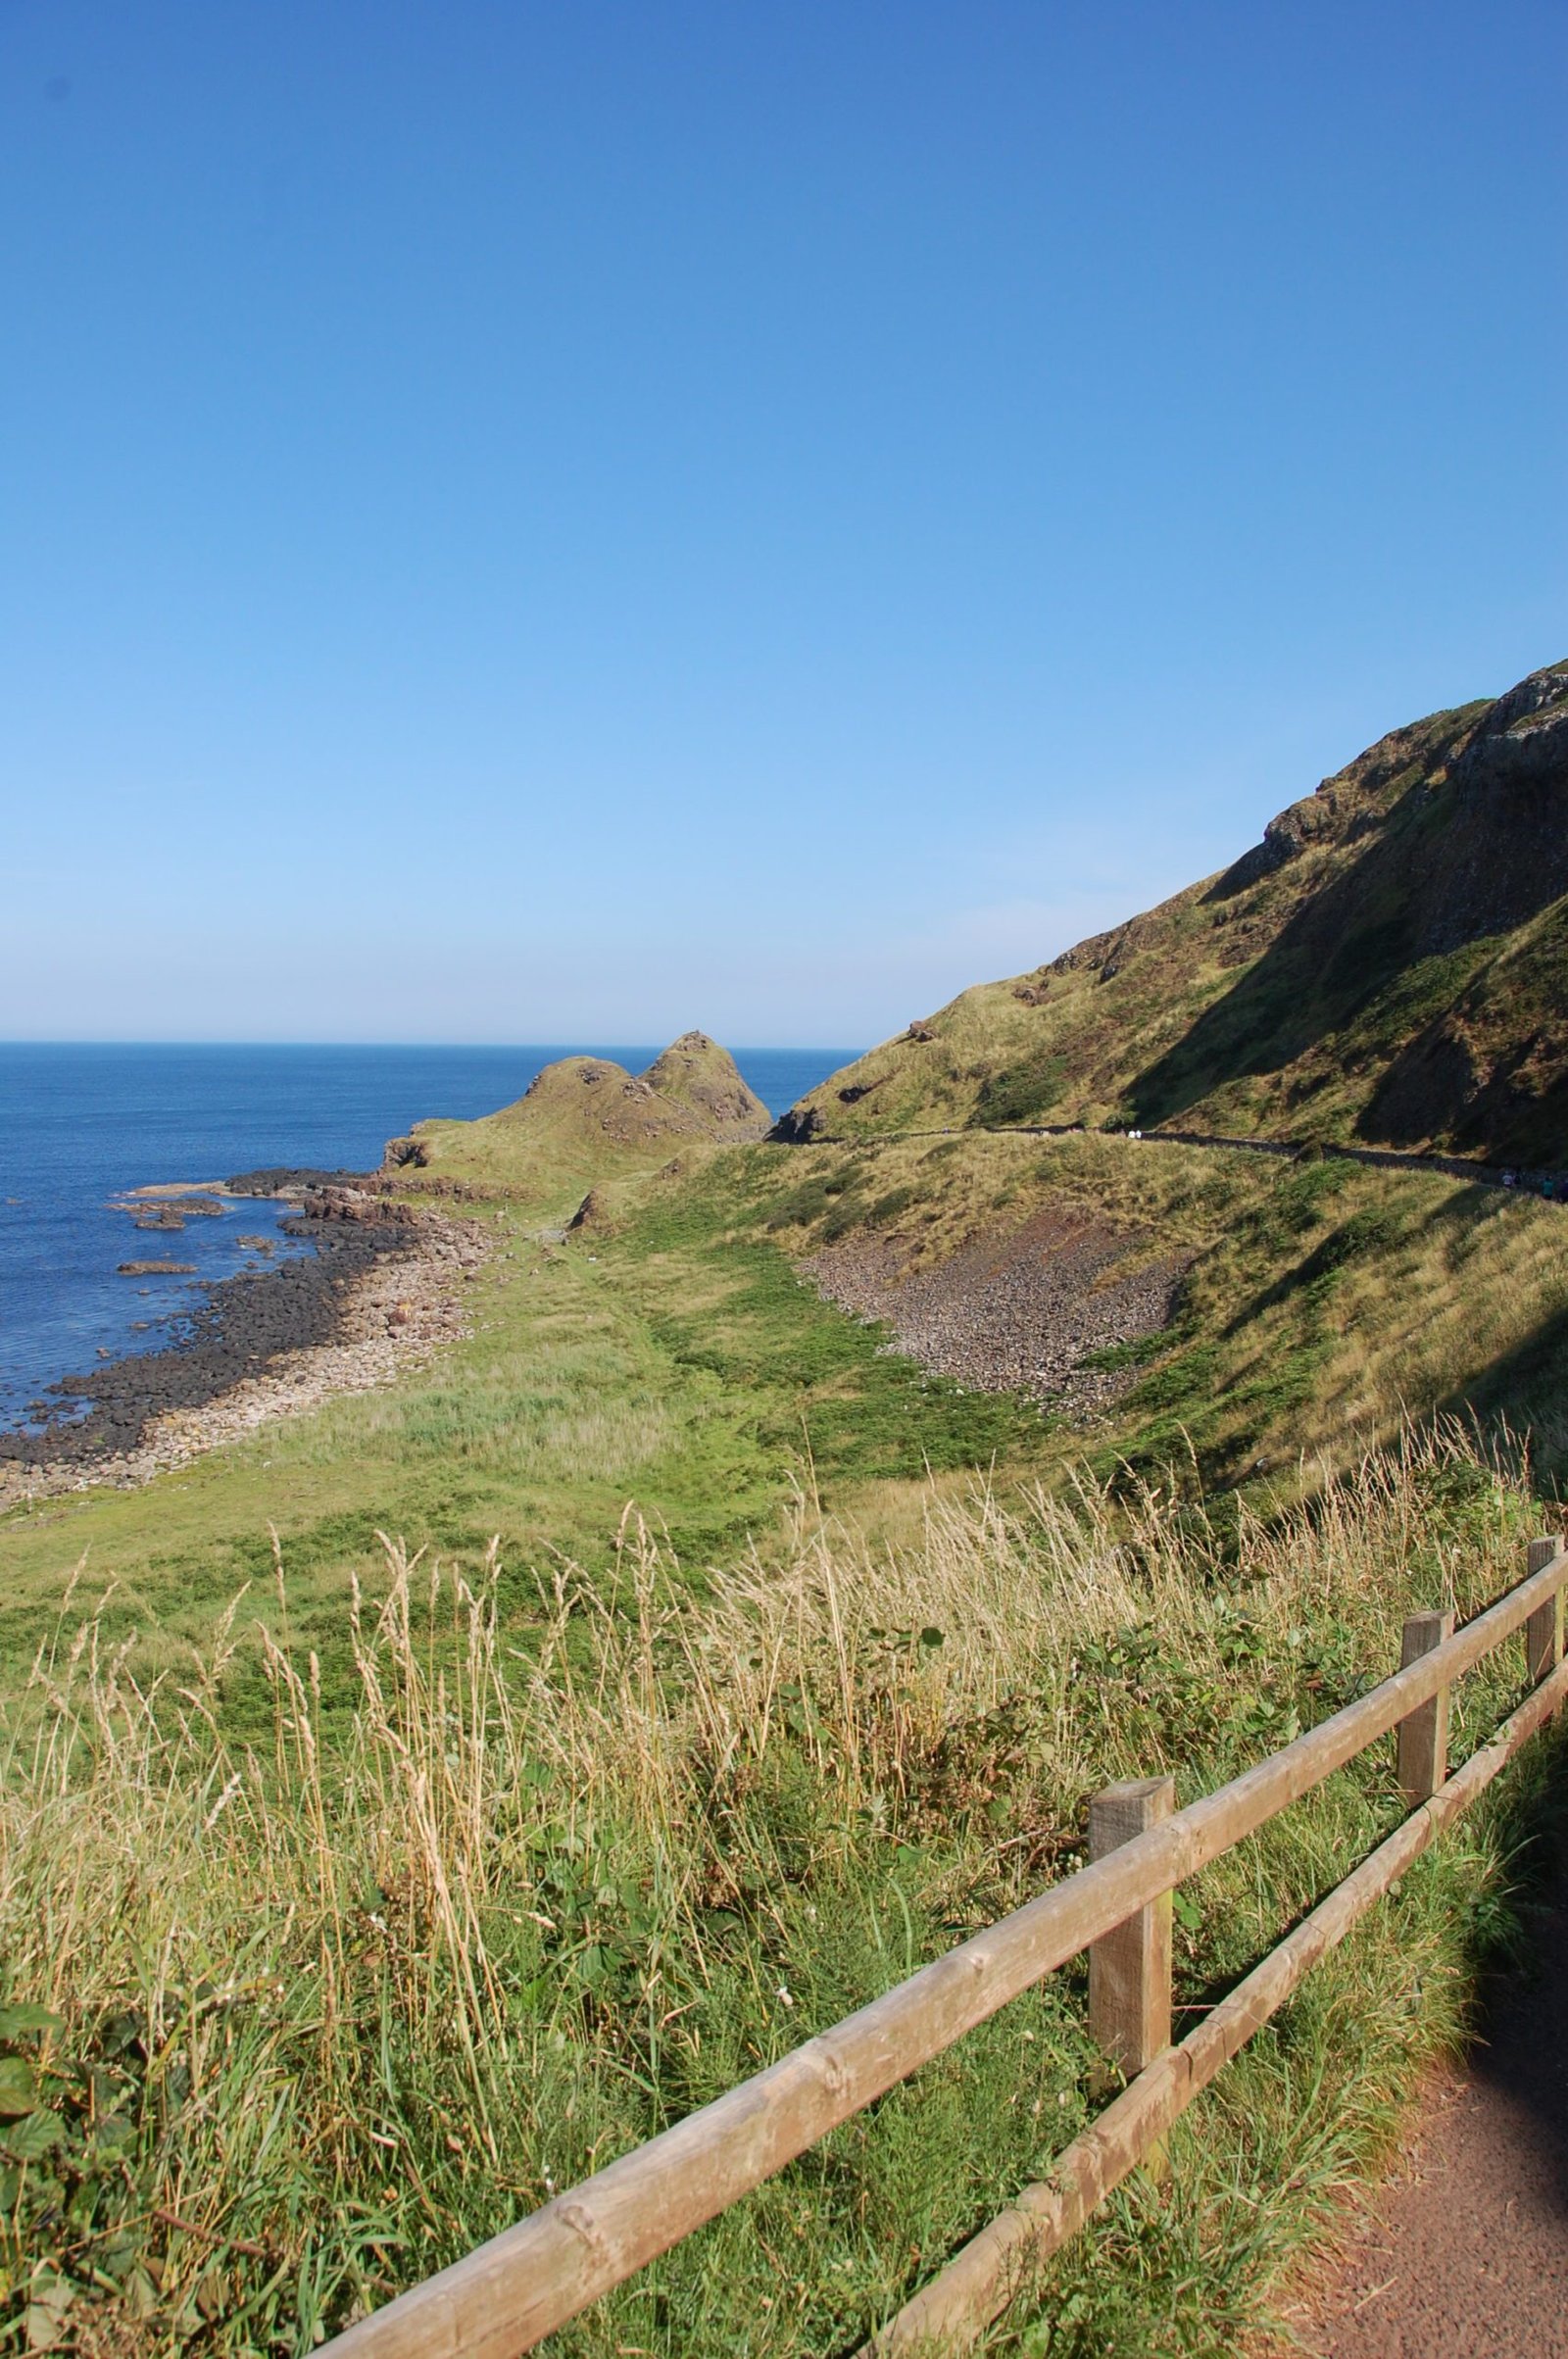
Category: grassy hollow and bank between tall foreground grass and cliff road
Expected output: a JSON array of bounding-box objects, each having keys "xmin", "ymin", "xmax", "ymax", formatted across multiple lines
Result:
[{"xmin": 0, "ymin": 1125, "xmax": 1568, "ymax": 1698}]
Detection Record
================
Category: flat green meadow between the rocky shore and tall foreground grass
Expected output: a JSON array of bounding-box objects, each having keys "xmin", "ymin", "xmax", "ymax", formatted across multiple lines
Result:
[{"xmin": 0, "ymin": 1152, "xmax": 1040, "ymax": 1673}]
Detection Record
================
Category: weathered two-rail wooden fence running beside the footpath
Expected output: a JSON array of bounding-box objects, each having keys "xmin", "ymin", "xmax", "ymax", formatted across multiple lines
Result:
[{"xmin": 327, "ymin": 1536, "xmax": 1568, "ymax": 2359}]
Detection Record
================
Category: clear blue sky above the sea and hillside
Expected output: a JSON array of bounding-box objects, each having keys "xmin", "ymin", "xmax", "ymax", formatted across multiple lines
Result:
[{"xmin": 0, "ymin": 0, "xmax": 1568, "ymax": 1045}]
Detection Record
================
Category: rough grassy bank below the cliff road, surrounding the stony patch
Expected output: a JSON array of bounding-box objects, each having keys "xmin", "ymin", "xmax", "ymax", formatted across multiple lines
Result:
[{"xmin": 693, "ymin": 1132, "xmax": 1568, "ymax": 1489}]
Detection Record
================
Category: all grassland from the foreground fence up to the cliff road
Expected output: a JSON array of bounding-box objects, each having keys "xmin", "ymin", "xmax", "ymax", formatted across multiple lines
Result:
[{"xmin": 0, "ymin": 1113, "xmax": 1568, "ymax": 2359}]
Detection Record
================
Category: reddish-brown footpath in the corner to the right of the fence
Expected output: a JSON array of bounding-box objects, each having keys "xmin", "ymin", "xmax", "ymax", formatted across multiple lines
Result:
[{"xmin": 1292, "ymin": 1840, "xmax": 1568, "ymax": 2359}]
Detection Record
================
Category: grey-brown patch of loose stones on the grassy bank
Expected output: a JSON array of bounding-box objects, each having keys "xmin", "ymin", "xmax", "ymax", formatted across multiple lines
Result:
[{"xmin": 802, "ymin": 1210, "xmax": 1186, "ymax": 1413}]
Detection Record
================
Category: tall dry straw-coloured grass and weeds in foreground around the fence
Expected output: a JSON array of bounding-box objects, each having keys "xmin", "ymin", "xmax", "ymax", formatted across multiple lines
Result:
[{"xmin": 0, "ymin": 1430, "xmax": 1535, "ymax": 2352}]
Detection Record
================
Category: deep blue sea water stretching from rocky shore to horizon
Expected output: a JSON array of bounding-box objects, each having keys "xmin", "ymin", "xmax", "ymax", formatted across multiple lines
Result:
[{"xmin": 0, "ymin": 1043, "xmax": 856, "ymax": 1427}]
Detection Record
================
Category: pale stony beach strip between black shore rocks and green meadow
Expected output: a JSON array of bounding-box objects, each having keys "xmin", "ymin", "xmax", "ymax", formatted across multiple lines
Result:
[{"xmin": 0, "ymin": 1172, "xmax": 486, "ymax": 1507}]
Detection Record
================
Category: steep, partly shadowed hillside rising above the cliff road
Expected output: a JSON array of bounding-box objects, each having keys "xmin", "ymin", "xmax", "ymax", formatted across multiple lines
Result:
[{"xmin": 780, "ymin": 665, "xmax": 1568, "ymax": 1163}]
